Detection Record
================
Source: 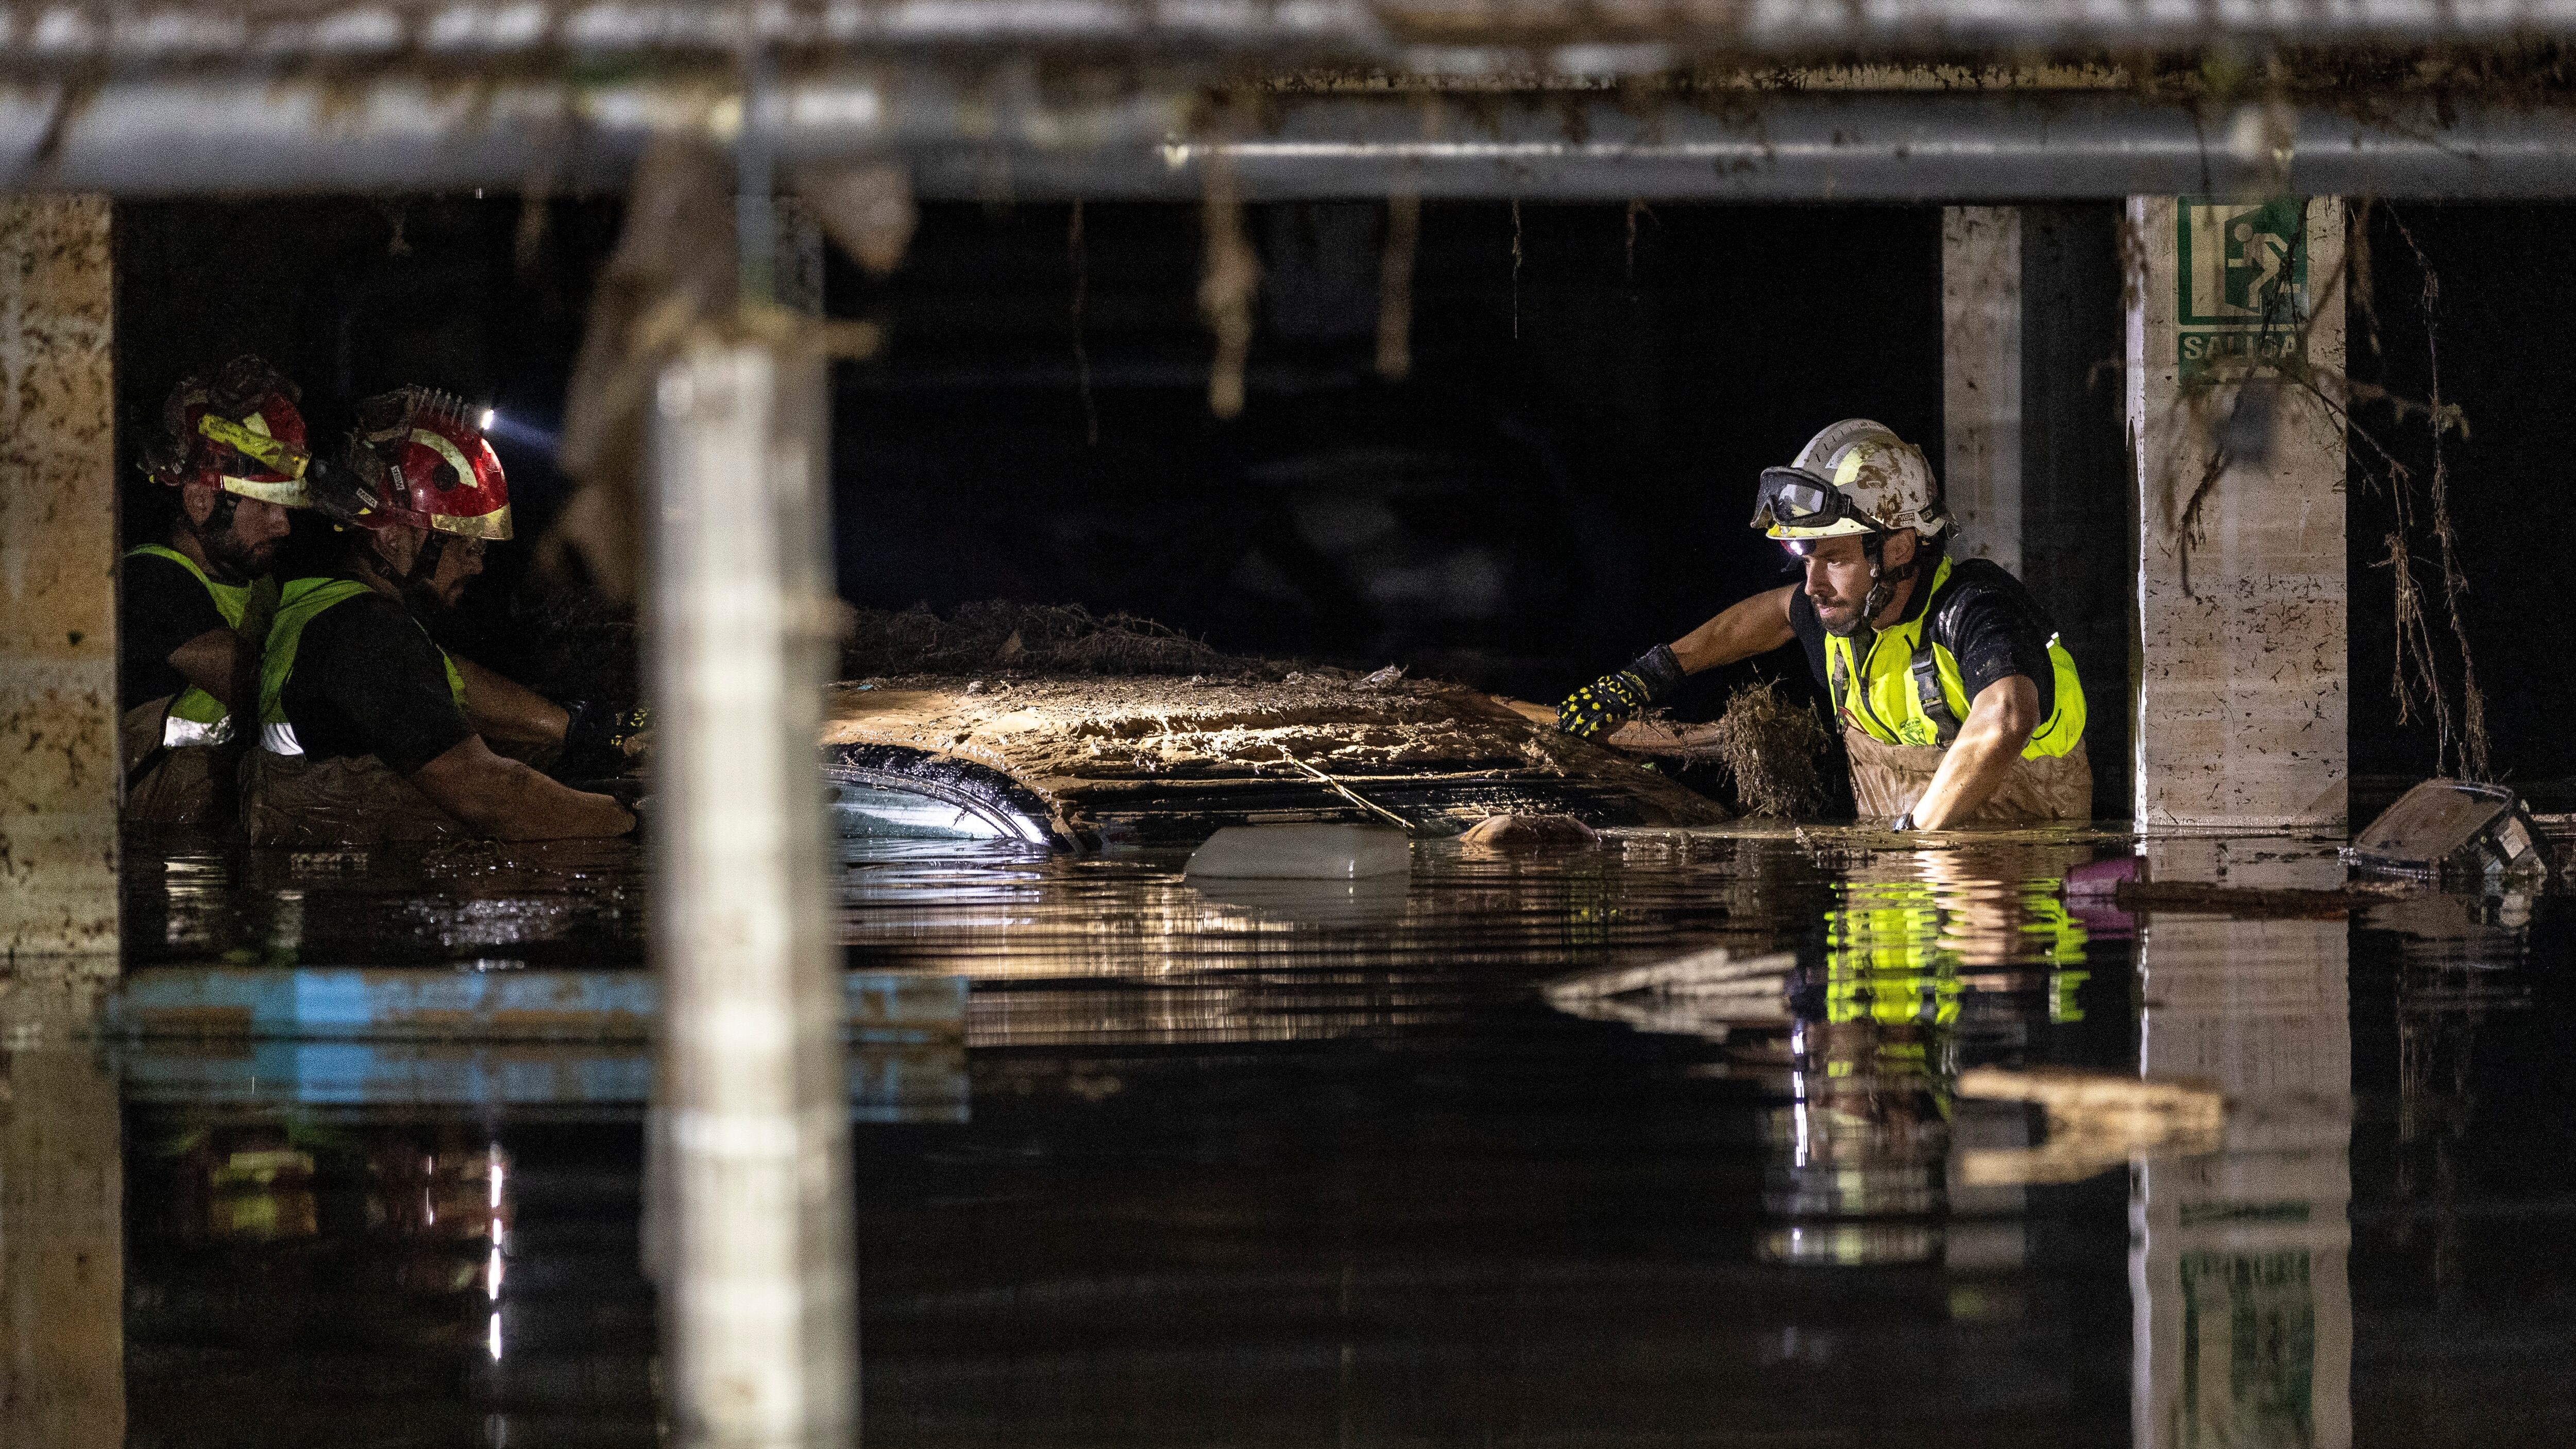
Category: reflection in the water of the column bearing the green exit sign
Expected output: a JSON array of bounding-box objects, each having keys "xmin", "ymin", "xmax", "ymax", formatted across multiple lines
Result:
[{"xmin": 2128, "ymin": 911, "xmax": 2352, "ymax": 1449}]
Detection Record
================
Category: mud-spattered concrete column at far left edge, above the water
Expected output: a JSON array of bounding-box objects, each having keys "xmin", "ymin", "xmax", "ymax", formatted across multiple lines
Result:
[{"xmin": 0, "ymin": 196, "xmax": 121, "ymax": 970}]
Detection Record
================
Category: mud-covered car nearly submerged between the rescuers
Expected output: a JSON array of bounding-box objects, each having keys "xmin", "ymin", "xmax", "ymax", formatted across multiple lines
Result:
[{"xmin": 824, "ymin": 672, "xmax": 1728, "ymax": 849}]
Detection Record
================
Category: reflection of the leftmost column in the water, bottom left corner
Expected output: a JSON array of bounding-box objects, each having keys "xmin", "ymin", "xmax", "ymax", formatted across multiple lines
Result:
[{"xmin": 0, "ymin": 970, "xmax": 126, "ymax": 1449}]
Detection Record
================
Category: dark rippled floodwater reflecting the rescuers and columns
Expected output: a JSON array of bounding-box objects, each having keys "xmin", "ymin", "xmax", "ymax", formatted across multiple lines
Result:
[{"xmin": 0, "ymin": 831, "xmax": 2576, "ymax": 1449}]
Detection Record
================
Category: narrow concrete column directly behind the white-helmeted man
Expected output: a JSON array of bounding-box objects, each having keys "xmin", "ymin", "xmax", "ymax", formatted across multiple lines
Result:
[{"xmin": 1940, "ymin": 206, "xmax": 2022, "ymax": 574}]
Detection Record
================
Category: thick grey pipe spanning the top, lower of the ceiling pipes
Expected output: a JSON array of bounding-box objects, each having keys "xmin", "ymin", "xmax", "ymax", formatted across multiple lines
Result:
[{"xmin": 15, "ymin": 67, "xmax": 2576, "ymax": 201}]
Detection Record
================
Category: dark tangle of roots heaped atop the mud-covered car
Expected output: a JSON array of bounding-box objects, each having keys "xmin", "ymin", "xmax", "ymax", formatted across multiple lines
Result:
[{"xmin": 842, "ymin": 600, "xmax": 1265, "ymax": 677}]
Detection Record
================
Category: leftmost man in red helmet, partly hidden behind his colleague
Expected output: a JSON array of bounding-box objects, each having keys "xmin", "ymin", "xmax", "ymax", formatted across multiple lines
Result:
[{"xmin": 116, "ymin": 355, "xmax": 312, "ymax": 826}]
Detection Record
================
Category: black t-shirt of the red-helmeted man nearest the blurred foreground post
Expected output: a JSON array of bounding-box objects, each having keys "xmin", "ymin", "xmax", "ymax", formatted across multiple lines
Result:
[{"xmin": 281, "ymin": 594, "xmax": 474, "ymax": 775}]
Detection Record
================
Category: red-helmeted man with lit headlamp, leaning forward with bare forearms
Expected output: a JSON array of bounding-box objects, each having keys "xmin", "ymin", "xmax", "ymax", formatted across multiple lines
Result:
[{"xmin": 245, "ymin": 388, "xmax": 636, "ymax": 844}]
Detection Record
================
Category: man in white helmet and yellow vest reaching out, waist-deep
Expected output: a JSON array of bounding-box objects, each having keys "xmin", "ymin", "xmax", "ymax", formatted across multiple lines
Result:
[{"xmin": 1556, "ymin": 417, "xmax": 2092, "ymax": 829}]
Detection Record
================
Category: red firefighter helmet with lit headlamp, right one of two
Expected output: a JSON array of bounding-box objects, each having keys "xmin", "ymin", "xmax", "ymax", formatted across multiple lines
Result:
[{"xmin": 332, "ymin": 388, "xmax": 510, "ymax": 540}]
